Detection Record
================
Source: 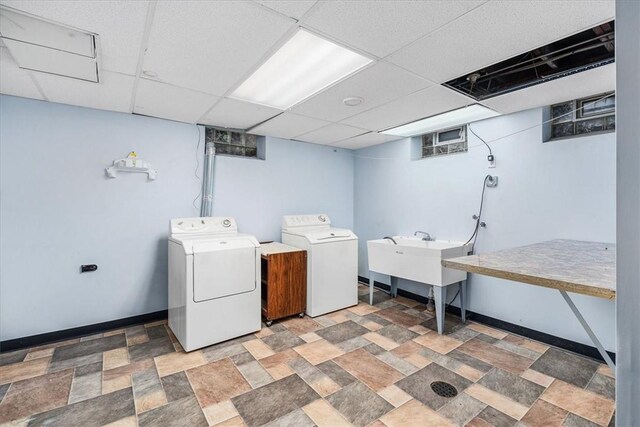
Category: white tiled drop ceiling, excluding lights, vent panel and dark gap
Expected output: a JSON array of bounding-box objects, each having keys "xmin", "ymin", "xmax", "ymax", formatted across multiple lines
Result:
[{"xmin": 0, "ymin": 0, "xmax": 615, "ymax": 149}]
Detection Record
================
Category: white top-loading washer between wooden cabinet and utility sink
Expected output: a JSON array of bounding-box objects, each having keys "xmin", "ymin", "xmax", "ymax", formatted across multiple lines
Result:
[{"xmin": 282, "ymin": 215, "xmax": 358, "ymax": 317}]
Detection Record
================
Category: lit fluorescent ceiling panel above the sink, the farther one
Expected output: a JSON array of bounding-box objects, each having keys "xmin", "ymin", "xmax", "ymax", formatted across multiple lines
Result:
[{"xmin": 380, "ymin": 104, "xmax": 500, "ymax": 137}]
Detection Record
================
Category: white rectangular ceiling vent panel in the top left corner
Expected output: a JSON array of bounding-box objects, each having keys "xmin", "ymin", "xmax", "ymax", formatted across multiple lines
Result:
[{"xmin": 0, "ymin": 6, "xmax": 99, "ymax": 83}]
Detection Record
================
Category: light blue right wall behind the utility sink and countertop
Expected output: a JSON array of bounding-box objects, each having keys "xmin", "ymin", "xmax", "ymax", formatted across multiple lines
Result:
[{"xmin": 355, "ymin": 109, "xmax": 616, "ymax": 350}]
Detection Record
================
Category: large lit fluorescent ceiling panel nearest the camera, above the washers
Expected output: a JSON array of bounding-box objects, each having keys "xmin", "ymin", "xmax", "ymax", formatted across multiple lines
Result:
[{"xmin": 230, "ymin": 29, "xmax": 372, "ymax": 110}]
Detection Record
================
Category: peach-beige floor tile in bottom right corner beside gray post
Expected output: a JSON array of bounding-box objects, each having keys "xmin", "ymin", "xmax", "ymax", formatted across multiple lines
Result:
[{"xmin": 540, "ymin": 380, "xmax": 615, "ymax": 425}]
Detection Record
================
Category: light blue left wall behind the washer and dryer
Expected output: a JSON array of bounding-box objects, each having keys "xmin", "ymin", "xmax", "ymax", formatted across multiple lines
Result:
[{"xmin": 0, "ymin": 96, "xmax": 353, "ymax": 340}]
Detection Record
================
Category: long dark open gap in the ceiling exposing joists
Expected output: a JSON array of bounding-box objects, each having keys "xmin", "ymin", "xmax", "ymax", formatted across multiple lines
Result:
[{"xmin": 445, "ymin": 21, "xmax": 615, "ymax": 101}]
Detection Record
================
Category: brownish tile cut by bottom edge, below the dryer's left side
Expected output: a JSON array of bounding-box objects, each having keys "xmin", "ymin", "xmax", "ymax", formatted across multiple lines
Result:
[{"xmin": 138, "ymin": 397, "xmax": 209, "ymax": 427}]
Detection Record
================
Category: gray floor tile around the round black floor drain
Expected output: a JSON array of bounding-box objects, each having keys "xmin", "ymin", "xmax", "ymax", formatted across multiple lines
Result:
[{"xmin": 396, "ymin": 363, "xmax": 472, "ymax": 410}]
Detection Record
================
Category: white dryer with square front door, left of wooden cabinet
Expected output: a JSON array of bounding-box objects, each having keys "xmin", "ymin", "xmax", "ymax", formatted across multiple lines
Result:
[{"xmin": 169, "ymin": 217, "xmax": 261, "ymax": 351}]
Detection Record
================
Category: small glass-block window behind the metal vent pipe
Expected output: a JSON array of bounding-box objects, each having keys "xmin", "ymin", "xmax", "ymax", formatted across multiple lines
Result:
[{"xmin": 205, "ymin": 126, "xmax": 265, "ymax": 160}]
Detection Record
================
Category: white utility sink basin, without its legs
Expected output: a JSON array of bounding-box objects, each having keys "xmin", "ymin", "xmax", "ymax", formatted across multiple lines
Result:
[{"xmin": 367, "ymin": 236, "xmax": 471, "ymax": 286}]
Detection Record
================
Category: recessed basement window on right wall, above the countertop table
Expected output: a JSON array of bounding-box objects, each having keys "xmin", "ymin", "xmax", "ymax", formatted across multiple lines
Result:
[{"xmin": 543, "ymin": 92, "xmax": 616, "ymax": 142}]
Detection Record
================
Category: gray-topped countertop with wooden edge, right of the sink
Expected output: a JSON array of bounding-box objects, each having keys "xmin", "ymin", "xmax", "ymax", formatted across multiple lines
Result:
[{"xmin": 442, "ymin": 240, "xmax": 616, "ymax": 299}]
